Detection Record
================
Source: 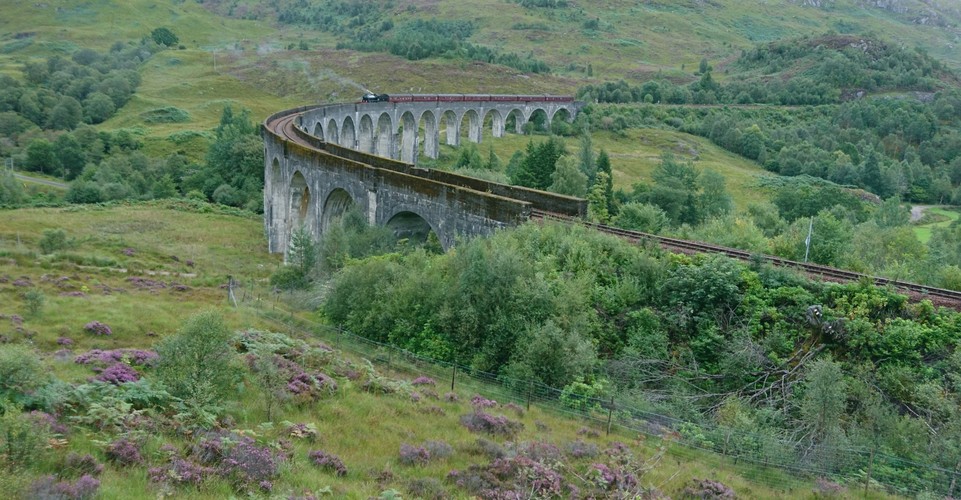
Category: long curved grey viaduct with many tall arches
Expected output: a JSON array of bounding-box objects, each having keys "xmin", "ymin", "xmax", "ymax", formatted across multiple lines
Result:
[{"xmin": 262, "ymin": 94, "xmax": 586, "ymax": 254}]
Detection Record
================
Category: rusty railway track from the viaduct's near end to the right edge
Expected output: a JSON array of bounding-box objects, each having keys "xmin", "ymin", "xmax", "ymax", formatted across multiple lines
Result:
[{"xmin": 531, "ymin": 210, "xmax": 961, "ymax": 308}]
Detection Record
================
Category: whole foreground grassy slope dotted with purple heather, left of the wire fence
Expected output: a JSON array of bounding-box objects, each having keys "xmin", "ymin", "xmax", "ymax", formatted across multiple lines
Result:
[{"xmin": 0, "ymin": 202, "xmax": 844, "ymax": 499}]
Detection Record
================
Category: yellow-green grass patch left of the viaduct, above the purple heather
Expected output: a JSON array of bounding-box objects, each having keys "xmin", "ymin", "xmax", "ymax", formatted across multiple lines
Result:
[{"xmin": 0, "ymin": 202, "xmax": 278, "ymax": 364}]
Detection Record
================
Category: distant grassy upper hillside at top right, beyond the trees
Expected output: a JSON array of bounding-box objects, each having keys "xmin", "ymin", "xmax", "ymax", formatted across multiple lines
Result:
[{"xmin": 384, "ymin": 0, "xmax": 961, "ymax": 79}]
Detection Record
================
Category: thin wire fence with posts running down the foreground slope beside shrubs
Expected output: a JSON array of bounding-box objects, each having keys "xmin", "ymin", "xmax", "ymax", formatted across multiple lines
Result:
[{"xmin": 238, "ymin": 288, "xmax": 961, "ymax": 498}]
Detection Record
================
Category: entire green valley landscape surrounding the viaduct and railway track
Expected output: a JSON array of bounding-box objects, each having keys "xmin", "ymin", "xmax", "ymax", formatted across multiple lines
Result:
[{"xmin": 0, "ymin": 0, "xmax": 961, "ymax": 499}]
